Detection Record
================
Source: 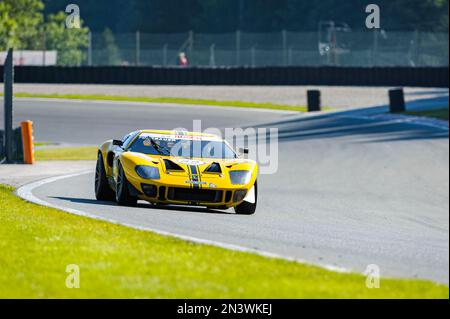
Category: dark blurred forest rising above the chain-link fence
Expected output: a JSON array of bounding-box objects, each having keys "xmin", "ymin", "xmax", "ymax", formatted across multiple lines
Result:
[{"xmin": 45, "ymin": 0, "xmax": 449, "ymax": 33}]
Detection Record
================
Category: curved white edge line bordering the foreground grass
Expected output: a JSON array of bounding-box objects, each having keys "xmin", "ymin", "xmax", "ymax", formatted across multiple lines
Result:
[{"xmin": 15, "ymin": 171, "xmax": 352, "ymax": 273}]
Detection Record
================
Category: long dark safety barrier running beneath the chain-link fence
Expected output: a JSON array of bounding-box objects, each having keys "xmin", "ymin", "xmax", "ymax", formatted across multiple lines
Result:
[{"xmin": 0, "ymin": 66, "xmax": 449, "ymax": 87}]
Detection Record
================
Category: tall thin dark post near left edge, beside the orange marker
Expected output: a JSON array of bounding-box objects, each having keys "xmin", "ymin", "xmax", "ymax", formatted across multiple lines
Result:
[{"xmin": 3, "ymin": 49, "xmax": 14, "ymax": 163}]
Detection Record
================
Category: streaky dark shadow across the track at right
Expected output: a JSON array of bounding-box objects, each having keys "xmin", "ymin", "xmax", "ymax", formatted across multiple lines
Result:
[{"xmin": 251, "ymin": 95, "xmax": 448, "ymax": 143}]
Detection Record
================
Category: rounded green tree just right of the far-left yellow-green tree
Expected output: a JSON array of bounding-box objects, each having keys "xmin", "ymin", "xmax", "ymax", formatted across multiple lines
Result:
[{"xmin": 43, "ymin": 12, "xmax": 89, "ymax": 65}]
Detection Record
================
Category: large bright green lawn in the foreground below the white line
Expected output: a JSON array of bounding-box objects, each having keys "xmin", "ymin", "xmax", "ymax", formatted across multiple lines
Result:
[{"xmin": 0, "ymin": 185, "xmax": 449, "ymax": 299}]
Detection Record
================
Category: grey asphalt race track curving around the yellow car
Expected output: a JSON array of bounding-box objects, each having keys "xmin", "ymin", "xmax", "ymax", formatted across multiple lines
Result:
[{"xmin": 3, "ymin": 101, "xmax": 449, "ymax": 283}]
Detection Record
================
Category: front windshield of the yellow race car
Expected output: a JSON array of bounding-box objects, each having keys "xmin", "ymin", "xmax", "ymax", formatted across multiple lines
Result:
[{"xmin": 128, "ymin": 134, "xmax": 236, "ymax": 158}]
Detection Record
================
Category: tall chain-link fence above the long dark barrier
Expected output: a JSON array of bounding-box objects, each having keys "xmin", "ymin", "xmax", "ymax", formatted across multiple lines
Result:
[{"xmin": 53, "ymin": 30, "xmax": 449, "ymax": 67}]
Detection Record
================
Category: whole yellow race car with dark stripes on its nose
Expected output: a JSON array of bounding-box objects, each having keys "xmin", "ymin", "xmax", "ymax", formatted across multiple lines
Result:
[{"xmin": 95, "ymin": 130, "xmax": 258, "ymax": 215}]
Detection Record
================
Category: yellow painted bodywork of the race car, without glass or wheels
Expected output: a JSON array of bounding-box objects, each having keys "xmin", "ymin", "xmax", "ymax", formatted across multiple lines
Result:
[{"xmin": 99, "ymin": 130, "xmax": 258, "ymax": 208}]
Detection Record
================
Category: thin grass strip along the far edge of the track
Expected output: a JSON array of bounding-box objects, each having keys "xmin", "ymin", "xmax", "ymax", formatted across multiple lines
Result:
[{"xmin": 8, "ymin": 93, "xmax": 310, "ymax": 112}]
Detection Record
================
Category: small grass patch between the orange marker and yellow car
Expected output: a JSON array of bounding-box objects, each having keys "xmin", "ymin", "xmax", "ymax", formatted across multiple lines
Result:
[{"xmin": 34, "ymin": 146, "xmax": 97, "ymax": 161}]
